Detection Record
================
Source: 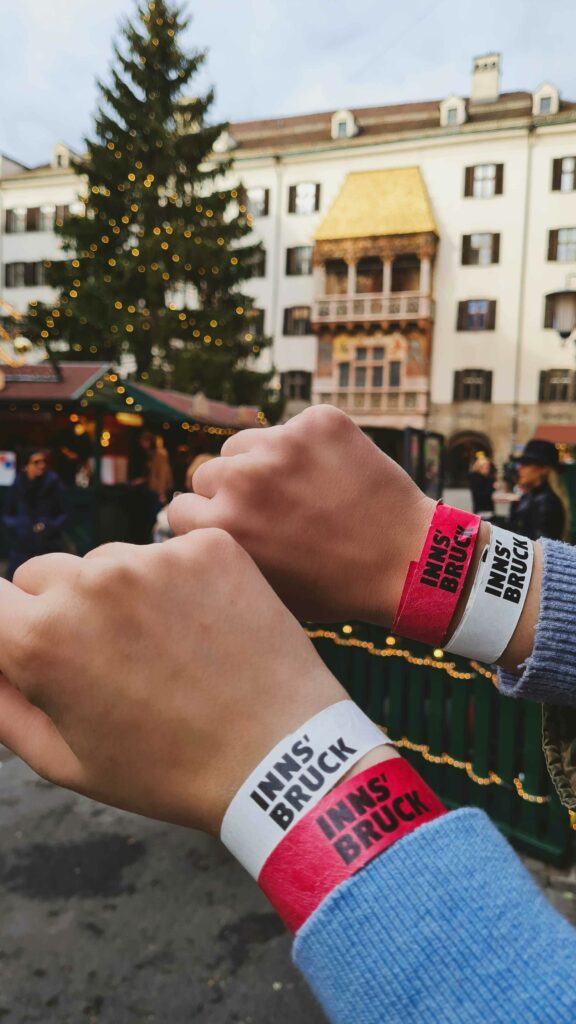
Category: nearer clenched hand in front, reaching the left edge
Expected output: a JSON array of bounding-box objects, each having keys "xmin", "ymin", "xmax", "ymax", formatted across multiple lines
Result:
[{"xmin": 0, "ymin": 529, "xmax": 346, "ymax": 833}]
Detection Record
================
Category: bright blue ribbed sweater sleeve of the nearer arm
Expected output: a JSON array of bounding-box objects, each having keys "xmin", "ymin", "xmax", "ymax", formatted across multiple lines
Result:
[{"xmin": 294, "ymin": 809, "xmax": 576, "ymax": 1024}]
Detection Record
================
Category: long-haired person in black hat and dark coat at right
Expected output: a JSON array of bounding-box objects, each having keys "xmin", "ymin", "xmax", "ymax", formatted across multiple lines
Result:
[{"xmin": 509, "ymin": 439, "xmax": 568, "ymax": 541}]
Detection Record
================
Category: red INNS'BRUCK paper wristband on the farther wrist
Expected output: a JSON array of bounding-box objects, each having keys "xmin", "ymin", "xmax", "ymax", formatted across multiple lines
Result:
[{"xmin": 393, "ymin": 502, "xmax": 481, "ymax": 644}]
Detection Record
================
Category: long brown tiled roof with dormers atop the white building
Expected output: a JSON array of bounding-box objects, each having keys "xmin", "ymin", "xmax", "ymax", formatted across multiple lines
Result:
[{"xmin": 230, "ymin": 91, "xmax": 576, "ymax": 154}]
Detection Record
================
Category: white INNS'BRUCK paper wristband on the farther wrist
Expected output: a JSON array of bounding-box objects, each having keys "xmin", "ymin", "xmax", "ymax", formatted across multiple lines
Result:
[{"xmin": 445, "ymin": 526, "xmax": 534, "ymax": 665}]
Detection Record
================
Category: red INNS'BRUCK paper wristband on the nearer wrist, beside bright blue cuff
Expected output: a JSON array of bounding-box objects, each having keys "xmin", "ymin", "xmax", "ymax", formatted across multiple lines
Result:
[{"xmin": 258, "ymin": 757, "xmax": 446, "ymax": 932}]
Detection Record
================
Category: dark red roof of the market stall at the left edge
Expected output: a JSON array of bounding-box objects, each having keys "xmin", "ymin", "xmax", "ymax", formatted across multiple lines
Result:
[{"xmin": 0, "ymin": 362, "xmax": 110, "ymax": 402}]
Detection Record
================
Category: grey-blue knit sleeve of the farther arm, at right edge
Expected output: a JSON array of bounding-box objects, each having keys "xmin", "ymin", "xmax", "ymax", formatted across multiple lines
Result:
[{"xmin": 498, "ymin": 541, "xmax": 576, "ymax": 705}]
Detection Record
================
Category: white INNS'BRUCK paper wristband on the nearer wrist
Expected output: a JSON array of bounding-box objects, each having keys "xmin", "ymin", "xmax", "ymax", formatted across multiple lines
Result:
[{"xmin": 220, "ymin": 700, "xmax": 389, "ymax": 879}]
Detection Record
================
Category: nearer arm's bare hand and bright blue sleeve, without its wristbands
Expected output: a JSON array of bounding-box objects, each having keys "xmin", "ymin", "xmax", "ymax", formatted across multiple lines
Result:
[{"xmin": 0, "ymin": 530, "xmax": 576, "ymax": 1024}]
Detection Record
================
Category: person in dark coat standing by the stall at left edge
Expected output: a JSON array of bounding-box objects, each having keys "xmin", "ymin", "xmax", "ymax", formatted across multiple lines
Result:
[{"xmin": 2, "ymin": 449, "xmax": 68, "ymax": 580}]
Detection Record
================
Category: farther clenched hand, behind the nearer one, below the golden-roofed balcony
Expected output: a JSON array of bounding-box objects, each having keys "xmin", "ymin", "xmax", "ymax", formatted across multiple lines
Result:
[{"xmin": 168, "ymin": 406, "xmax": 435, "ymax": 625}]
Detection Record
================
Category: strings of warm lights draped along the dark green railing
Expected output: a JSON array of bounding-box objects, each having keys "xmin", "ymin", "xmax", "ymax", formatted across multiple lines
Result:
[{"xmin": 305, "ymin": 626, "xmax": 549, "ymax": 806}]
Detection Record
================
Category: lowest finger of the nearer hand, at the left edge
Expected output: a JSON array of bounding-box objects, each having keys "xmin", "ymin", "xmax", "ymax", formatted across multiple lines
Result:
[{"xmin": 0, "ymin": 675, "xmax": 82, "ymax": 788}]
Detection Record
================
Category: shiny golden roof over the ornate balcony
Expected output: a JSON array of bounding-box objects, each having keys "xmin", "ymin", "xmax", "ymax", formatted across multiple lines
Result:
[{"xmin": 315, "ymin": 167, "xmax": 438, "ymax": 242}]
